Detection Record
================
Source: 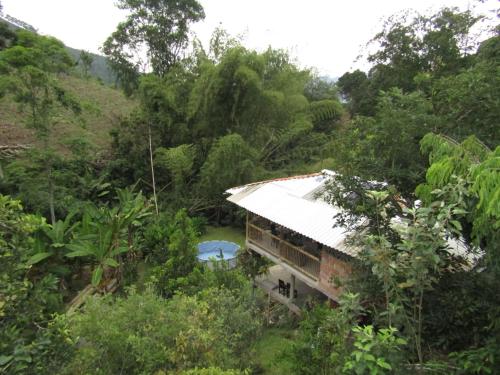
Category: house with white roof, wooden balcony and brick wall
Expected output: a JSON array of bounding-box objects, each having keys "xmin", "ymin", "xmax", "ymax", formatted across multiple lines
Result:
[{"xmin": 226, "ymin": 170, "xmax": 357, "ymax": 313}]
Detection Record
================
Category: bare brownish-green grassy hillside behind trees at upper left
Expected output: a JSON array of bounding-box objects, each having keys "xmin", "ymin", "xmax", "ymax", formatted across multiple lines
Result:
[{"xmin": 0, "ymin": 76, "xmax": 136, "ymax": 152}]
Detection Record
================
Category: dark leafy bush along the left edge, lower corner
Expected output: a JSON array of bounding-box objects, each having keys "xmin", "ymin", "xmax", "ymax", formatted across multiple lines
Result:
[{"xmin": 0, "ymin": 195, "xmax": 62, "ymax": 374}]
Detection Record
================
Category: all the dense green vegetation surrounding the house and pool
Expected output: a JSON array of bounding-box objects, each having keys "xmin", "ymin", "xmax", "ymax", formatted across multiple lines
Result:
[{"xmin": 0, "ymin": 0, "xmax": 500, "ymax": 375}]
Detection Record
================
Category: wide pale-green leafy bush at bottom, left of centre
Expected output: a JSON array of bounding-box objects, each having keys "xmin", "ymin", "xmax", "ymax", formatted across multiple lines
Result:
[{"xmin": 58, "ymin": 289, "xmax": 260, "ymax": 374}]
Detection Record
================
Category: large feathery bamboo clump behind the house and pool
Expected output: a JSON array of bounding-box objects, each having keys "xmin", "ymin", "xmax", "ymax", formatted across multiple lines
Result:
[{"xmin": 108, "ymin": 42, "xmax": 343, "ymax": 220}]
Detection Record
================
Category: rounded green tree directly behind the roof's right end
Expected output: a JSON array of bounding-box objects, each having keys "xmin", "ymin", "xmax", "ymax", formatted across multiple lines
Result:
[{"xmin": 334, "ymin": 89, "xmax": 440, "ymax": 194}]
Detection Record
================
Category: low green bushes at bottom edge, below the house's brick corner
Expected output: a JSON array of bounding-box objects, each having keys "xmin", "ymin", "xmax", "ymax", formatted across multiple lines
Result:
[{"xmin": 288, "ymin": 293, "xmax": 406, "ymax": 374}]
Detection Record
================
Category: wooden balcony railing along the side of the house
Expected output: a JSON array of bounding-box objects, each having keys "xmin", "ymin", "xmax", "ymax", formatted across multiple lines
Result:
[{"xmin": 247, "ymin": 223, "xmax": 320, "ymax": 280}]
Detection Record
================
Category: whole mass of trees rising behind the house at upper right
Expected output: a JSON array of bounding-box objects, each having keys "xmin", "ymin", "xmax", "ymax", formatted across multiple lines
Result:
[{"xmin": 335, "ymin": 9, "xmax": 500, "ymax": 194}]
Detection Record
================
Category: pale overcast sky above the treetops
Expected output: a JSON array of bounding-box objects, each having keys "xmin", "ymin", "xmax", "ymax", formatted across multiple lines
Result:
[{"xmin": 1, "ymin": 0, "xmax": 498, "ymax": 77}]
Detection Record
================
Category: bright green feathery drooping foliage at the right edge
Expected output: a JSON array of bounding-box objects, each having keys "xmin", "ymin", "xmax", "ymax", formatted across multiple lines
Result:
[{"xmin": 416, "ymin": 133, "xmax": 500, "ymax": 269}]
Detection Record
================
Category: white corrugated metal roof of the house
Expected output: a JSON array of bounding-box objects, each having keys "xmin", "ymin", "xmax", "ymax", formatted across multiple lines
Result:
[{"xmin": 227, "ymin": 170, "xmax": 357, "ymax": 256}]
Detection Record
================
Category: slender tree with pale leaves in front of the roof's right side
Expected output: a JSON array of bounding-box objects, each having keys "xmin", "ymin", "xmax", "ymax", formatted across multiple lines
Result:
[{"xmin": 356, "ymin": 180, "xmax": 474, "ymax": 366}]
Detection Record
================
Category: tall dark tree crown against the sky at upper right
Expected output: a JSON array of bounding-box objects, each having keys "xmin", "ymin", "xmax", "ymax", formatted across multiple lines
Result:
[{"xmin": 368, "ymin": 8, "xmax": 481, "ymax": 91}]
